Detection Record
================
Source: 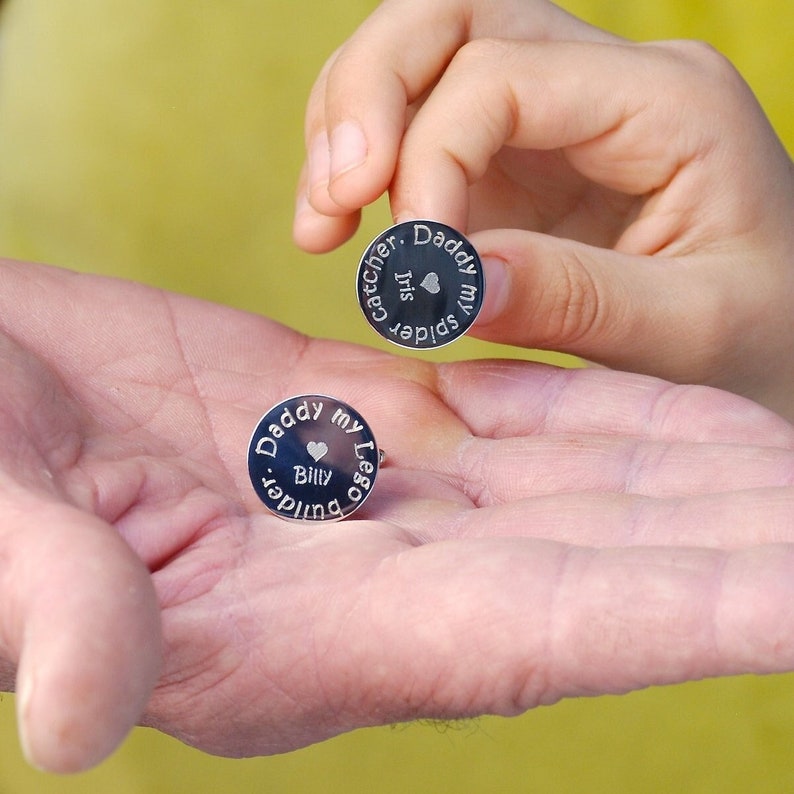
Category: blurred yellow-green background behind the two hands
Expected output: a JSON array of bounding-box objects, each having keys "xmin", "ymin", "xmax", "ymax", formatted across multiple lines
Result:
[{"xmin": 0, "ymin": 0, "xmax": 794, "ymax": 794}]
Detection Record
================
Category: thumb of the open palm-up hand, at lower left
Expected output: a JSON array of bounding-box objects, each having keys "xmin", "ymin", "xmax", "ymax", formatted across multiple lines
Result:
[{"xmin": 0, "ymin": 492, "xmax": 161, "ymax": 772}]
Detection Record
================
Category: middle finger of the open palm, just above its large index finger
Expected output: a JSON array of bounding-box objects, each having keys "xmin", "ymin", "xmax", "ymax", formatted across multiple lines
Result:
[{"xmin": 372, "ymin": 478, "xmax": 794, "ymax": 549}]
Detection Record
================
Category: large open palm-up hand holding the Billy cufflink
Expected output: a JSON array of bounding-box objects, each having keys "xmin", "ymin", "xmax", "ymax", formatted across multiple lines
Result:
[{"xmin": 0, "ymin": 262, "xmax": 794, "ymax": 771}]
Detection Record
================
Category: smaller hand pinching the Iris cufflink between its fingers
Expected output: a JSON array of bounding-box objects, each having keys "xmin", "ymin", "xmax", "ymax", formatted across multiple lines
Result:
[{"xmin": 295, "ymin": 0, "xmax": 794, "ymax": 418}]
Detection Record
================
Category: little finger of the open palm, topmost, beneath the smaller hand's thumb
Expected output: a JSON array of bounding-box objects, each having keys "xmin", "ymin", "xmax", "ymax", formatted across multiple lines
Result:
[{"xmin": 437, "ymin": 360, "xmax": 794, "ymax": 450}]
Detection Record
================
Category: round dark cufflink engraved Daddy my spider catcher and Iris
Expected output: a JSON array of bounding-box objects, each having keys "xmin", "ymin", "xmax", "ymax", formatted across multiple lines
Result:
[{"xmin": 356, "ymin": 220, "xmax": 485, "ymax": 350}]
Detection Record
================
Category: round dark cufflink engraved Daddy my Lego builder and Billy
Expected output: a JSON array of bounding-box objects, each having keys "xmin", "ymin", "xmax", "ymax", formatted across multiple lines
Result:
[{"xmin": 248, "ymin": 394, "xmax": 382, "ymax": 521}]
